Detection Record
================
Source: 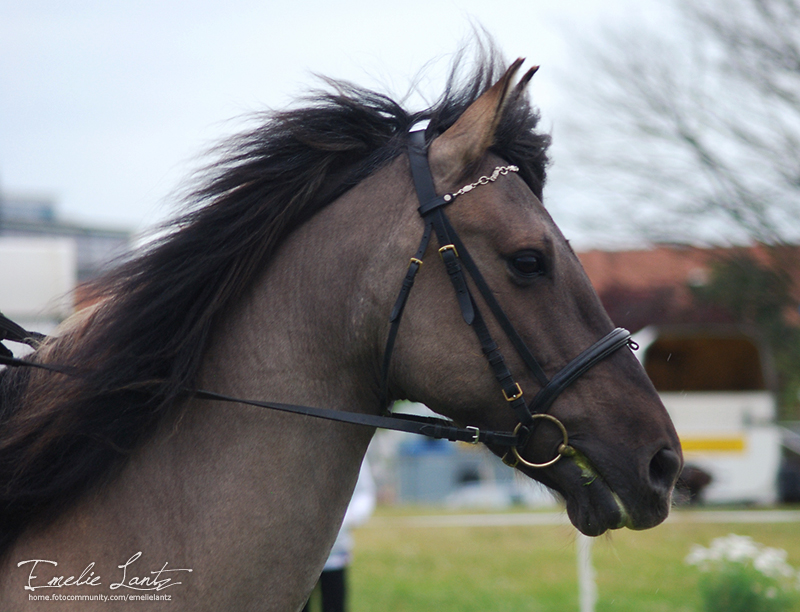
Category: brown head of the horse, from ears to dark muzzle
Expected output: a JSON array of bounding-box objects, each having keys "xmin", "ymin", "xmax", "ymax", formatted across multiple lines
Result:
[{"xmin": 389, "ymin": 60, "xmax": 682, "ymax": 535}]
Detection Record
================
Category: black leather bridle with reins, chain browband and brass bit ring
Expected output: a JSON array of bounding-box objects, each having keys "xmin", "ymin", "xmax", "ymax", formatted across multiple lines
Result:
[{"xmin": 0, "ymin": 130, "xmax": 635, "ymax": 468}]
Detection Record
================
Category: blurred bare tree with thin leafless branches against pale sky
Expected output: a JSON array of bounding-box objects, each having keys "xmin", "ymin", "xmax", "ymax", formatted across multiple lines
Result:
[{"xmin": 557, "ymin": 0, "xmax": 800, "ymax": 244}]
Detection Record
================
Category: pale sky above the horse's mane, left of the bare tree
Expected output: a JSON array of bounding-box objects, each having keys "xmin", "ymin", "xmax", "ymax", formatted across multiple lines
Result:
[{"xmin": 0, "ymin": 0, "xmax": 655, "ymax": 242}]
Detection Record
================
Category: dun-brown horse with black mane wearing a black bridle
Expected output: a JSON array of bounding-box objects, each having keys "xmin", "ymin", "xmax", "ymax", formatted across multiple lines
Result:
[{"xmin": 0, "ymin": 54, "xmax": 682, "ymax": 612}]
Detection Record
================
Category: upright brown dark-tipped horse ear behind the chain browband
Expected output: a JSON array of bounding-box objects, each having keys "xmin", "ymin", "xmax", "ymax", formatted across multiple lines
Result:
[{"xmin": 428, "ymin": 58, "xmax": 538, "ymax": 186}]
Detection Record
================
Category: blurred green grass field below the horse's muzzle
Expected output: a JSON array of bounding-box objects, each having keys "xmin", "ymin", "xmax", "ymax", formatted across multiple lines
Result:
[{"xmin": 349, "ymin": 508, "xmax": 800, "ymax": 612}]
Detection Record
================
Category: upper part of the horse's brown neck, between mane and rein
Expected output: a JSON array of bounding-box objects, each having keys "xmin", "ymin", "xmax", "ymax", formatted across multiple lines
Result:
[{"xmin": 201, "ymin": 164, "xmax": 416, "ymax": 413}]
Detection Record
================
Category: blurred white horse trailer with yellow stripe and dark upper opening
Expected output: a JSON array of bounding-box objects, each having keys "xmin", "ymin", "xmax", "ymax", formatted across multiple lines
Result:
[{"xmin": 633, "ymin": 326, "xmax": 781, "ymax": 504}]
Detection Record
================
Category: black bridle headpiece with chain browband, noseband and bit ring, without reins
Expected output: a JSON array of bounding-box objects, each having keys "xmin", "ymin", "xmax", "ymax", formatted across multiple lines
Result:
[{"xmin": 381, "ymin": 130, "xmax": 631, "ymax": 468}]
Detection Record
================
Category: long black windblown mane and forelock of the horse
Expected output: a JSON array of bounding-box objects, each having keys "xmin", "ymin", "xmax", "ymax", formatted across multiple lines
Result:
[{"xmin": 0, "ymin": 50, "xmax": 549, "ymax": 555}]
